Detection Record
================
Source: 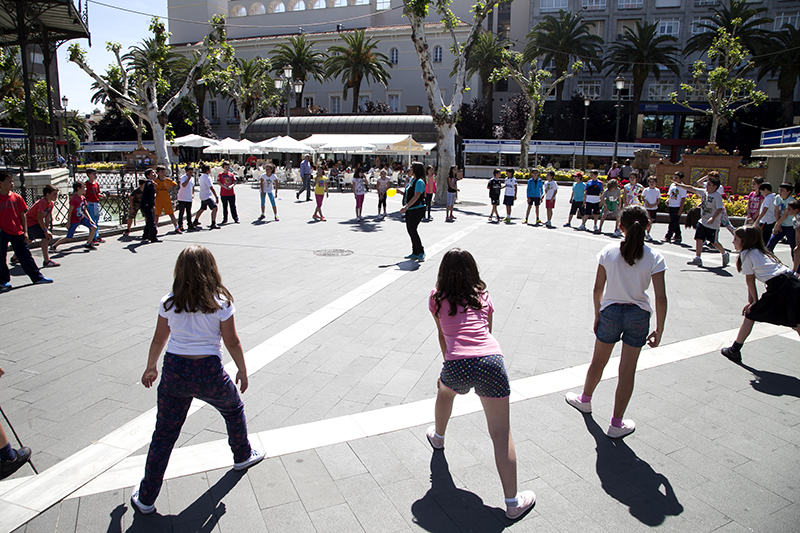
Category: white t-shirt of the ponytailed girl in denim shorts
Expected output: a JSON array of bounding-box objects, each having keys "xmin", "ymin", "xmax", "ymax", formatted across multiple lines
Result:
[{"xmin": 597, "ymin": 243, "xmax": 667, "ymax": 313}]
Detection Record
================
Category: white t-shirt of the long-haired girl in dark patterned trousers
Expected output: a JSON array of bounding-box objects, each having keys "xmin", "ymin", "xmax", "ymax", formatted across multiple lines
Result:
[{"xmin": 158, "ymin": 292, "xmax": 236, "ymax": 357}]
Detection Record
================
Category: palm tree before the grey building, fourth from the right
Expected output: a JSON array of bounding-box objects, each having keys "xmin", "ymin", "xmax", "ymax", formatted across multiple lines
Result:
[{"xmin": 524, "ymin": 9, "xmax": 604, "ymax": 102}]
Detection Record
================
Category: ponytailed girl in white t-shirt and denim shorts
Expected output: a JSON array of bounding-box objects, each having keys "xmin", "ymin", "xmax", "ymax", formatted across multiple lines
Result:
[{"xmin": 566, "ymin": 205, "xmax": 667, "ymax": 438}]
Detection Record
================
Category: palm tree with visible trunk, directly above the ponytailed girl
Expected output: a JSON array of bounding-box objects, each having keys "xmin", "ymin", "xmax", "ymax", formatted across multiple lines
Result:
[{"xmin": 608, "ymin": 21, "xmax": 680, "ymax": 137}]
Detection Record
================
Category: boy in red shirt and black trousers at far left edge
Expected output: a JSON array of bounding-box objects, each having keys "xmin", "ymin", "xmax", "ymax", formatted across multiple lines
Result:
[{"xmin": 0, "ymin": 171, "xmax": 53, "ymax": 292}]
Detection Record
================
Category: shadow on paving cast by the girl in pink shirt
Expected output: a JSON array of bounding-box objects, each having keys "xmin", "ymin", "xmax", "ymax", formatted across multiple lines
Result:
[{"xmin": 411, "ymin": 450, "xmax": 510, "ymax": 533}]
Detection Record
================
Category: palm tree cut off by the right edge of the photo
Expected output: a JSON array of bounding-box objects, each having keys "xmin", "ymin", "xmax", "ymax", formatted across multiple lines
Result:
[{"xmin": 754, "ymin": 24, "xmax": 800, "ymax": 126}]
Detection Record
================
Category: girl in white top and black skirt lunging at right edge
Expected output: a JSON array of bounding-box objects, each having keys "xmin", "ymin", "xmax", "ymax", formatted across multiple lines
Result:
[{"xmin": 722, "ymin": 226, "xmax": 800, "ymax": 363}]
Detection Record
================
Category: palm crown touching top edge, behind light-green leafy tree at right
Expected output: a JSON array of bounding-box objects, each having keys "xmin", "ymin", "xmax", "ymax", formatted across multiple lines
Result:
[{"xmin": 683, "ymin": 0, "xmax": 772, "ymax": 56}]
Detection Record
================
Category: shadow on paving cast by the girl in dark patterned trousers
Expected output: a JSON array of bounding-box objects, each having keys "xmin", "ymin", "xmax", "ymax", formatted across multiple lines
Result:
[{"xmin": 107, "ymin": 469, "xmax": 245, "ymax": 533}]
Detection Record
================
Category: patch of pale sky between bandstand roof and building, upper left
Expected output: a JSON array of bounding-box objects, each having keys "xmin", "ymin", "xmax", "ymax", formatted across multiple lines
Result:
[{"xmin": 58, "ymin": 0, "xmax": 169, "ymax": 113}]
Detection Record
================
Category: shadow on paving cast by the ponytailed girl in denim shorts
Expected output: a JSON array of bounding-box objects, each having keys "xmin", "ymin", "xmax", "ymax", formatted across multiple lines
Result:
[{"xmin": 583, "ymin": 414, "xmax": 683, "ymax": 527}]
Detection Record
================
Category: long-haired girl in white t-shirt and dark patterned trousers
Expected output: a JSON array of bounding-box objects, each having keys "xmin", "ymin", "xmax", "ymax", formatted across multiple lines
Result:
[{"xmin": 131, "ymin": 244, "xmax": 264, "ymax": 514}]
